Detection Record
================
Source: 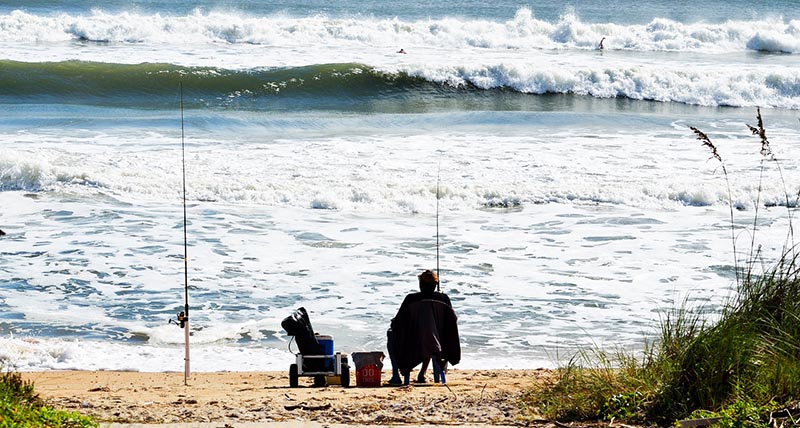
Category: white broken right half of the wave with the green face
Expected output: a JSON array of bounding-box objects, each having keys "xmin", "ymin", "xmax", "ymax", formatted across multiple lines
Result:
[{"xmin": 399, "ymin": 60, "xmax": 800, "ymax": 109}]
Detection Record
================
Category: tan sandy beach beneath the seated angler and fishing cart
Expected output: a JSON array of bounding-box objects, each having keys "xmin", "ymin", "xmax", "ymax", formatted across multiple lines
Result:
[{"xmin": 24, "ymin": 369, "xmax": 548, "ymax": 426}]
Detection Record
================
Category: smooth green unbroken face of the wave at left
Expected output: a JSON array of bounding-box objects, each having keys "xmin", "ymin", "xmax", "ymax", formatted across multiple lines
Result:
[{"xmin": 0, "ymin": 60, "xmax": 448, "ymax": 104}]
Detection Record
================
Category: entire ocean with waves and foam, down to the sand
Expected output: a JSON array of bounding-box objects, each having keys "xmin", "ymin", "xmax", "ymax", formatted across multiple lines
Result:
[{"xmin": 0, "ymin": 0, "xmax": 800, "ymax": 371}]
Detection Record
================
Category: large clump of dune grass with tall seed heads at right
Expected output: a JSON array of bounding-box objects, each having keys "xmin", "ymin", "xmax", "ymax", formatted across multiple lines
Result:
[{"xmin": 520, "ymin": 111, "xmax": 800, "ymax": 427}]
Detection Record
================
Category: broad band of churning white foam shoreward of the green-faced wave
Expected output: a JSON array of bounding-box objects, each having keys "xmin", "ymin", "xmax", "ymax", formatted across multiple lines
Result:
[{"xmin": 0, "ymin": 118, "xmax": 800, "ymax": 213}]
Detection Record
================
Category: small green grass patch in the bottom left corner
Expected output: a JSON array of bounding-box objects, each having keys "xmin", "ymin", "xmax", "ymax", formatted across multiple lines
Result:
[{"xmin": 0, "ymin": 366, "xmax": 98, "ymax": 428}]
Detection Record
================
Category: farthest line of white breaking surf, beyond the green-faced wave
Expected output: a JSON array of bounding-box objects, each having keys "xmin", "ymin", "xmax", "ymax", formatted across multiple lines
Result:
[{"xmin": 0, "ymin": 7, "xmax": 800, "ymax": 54}]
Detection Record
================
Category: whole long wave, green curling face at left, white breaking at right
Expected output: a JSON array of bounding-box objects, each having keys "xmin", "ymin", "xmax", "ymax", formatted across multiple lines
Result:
[{"xmin": 0, "ymin": 60, "xmax": 800, "ymax": 110}]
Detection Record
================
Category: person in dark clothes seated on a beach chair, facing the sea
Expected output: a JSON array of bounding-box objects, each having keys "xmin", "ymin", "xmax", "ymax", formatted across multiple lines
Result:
[{"xmin": 386, "ymin": 270, "xmax": 461, "ymax": 385}]
